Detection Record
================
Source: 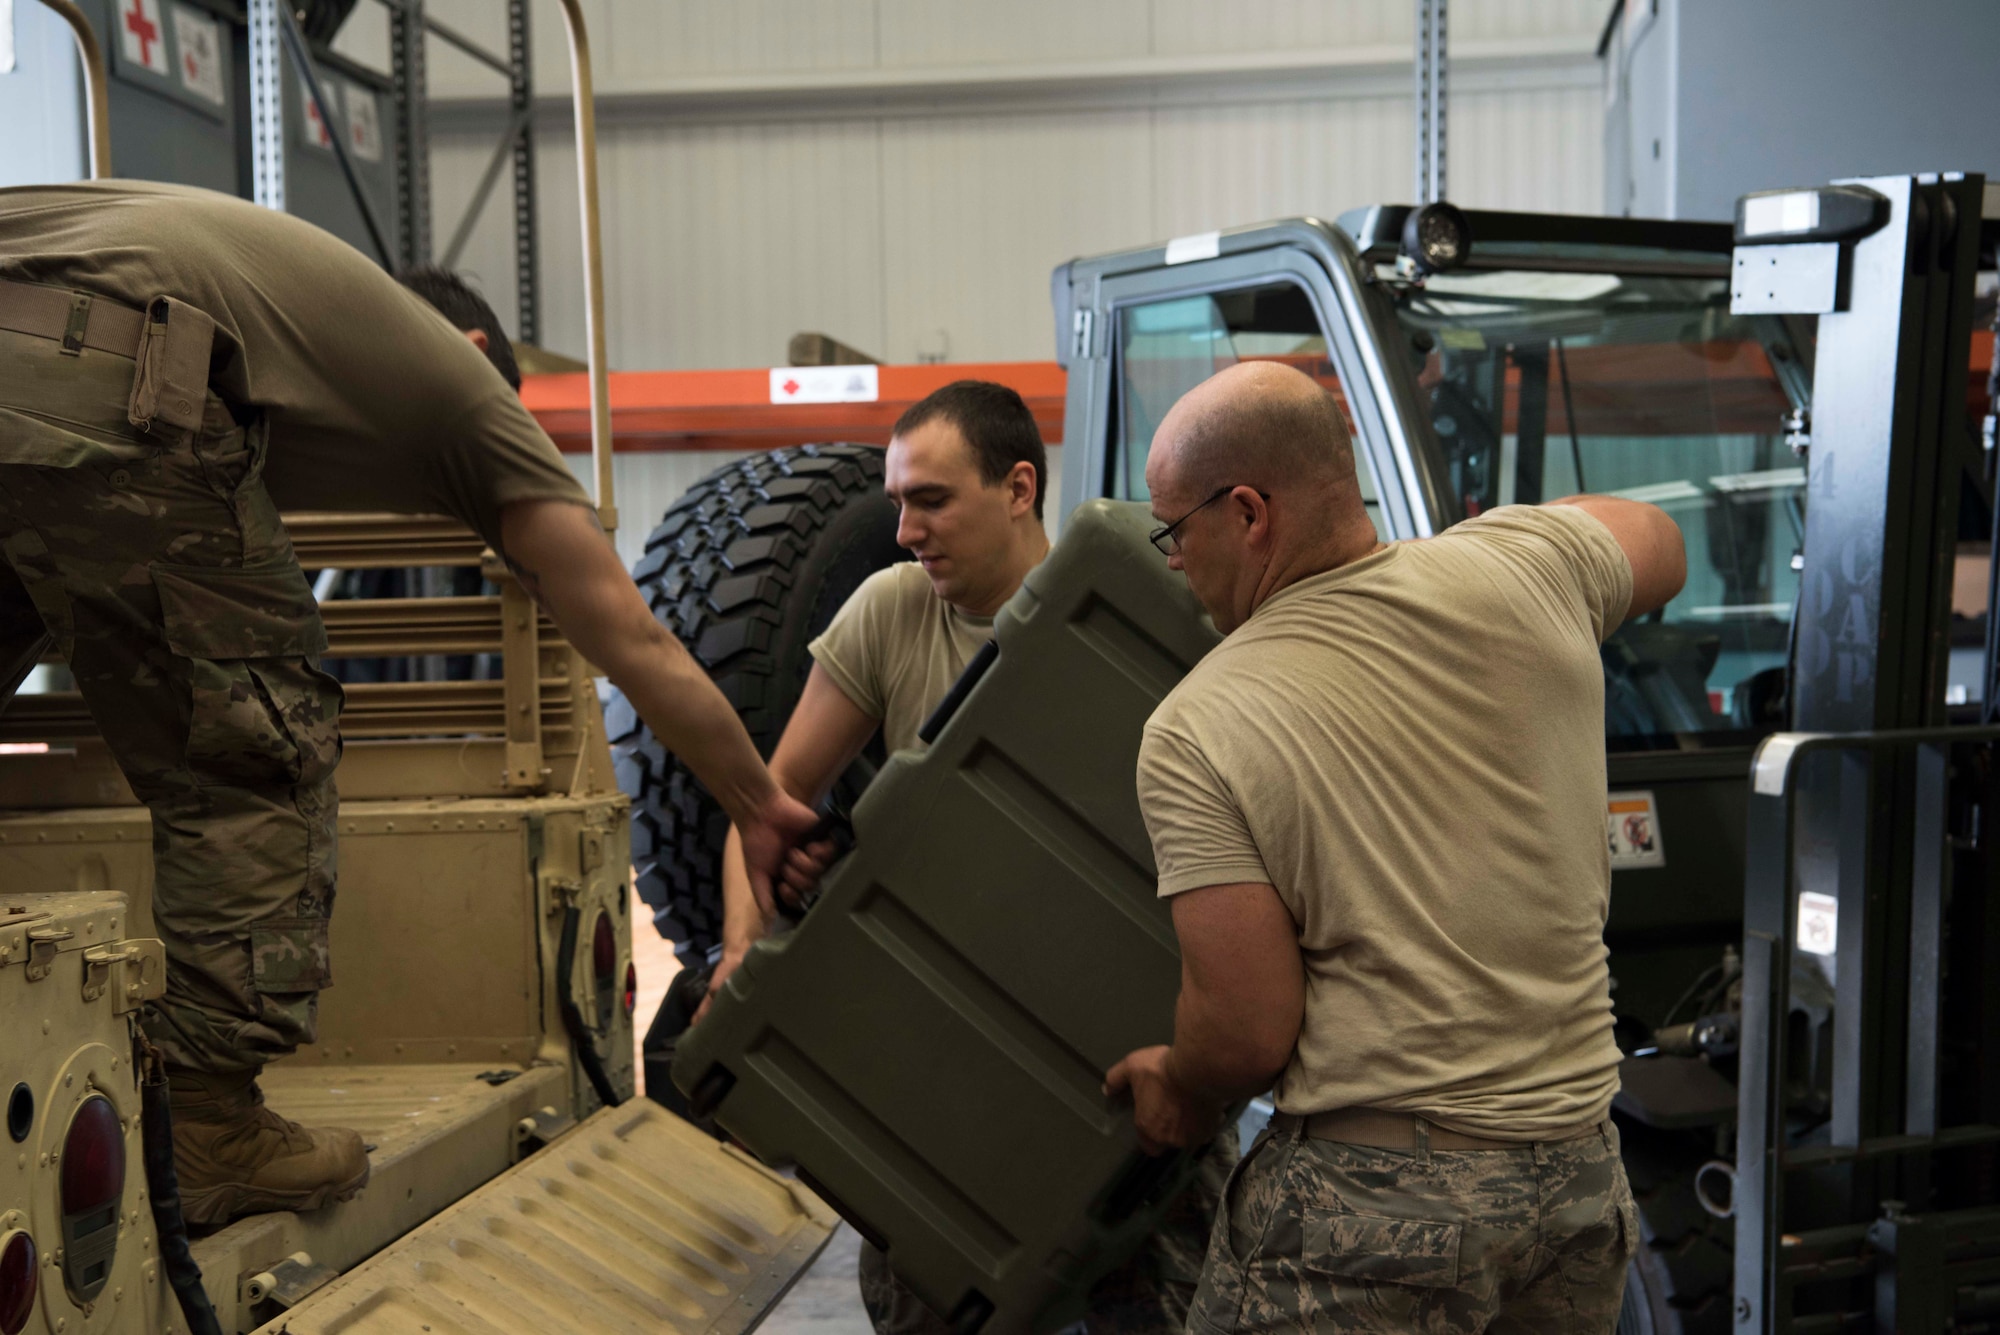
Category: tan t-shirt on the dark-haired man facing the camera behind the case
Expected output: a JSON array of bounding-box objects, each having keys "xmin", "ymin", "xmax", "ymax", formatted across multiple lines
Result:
[{"xmin": 806, "ymin": 562, "xmax": 994, "ymax": 751}]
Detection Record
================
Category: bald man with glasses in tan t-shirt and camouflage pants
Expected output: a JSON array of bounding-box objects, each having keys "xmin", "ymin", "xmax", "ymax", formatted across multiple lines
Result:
[{"xmin": 1106, "ymin": 362, "xmax": 1686, "ymax": 1335}]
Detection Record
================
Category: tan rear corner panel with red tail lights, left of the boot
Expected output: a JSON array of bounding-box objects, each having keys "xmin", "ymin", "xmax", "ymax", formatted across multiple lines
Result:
[{"xmin": 0, "ymin": 881, "xmax": 178, "ymax": 1335}]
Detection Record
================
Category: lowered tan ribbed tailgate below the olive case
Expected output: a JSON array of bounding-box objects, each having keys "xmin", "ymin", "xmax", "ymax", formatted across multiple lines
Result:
[{"xmin": 242, "ymin": 1099, "xmax": 838, "ymax": 1335}]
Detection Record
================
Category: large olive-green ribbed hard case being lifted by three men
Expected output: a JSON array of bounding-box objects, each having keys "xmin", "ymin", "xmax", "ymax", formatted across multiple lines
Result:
[{"xmin": 674, "ymin": 502, "xmax": 1216, "ymax": 1333}]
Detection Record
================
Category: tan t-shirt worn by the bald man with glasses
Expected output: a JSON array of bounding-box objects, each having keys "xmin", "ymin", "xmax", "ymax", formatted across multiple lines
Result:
[{"xmin": 1138, "ymin": 506, "xmax": 1632, "ymax": 1139}]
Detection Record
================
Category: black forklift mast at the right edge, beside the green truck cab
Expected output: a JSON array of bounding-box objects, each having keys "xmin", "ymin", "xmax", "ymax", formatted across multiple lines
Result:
[{"xmin": 1732, "ymin": 174, "xmax": 2000, "ymax": 1333}]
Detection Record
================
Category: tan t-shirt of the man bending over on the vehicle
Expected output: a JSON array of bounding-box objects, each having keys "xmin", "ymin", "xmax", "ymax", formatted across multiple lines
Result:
[{"xmin": 0, "ymin": 180, "xmax": 588, "ymax": 550}]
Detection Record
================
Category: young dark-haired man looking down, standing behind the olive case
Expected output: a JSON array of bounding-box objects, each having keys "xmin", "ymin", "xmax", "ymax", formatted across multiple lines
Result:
[{"xmin": 704, "ymin": 380, "xmax": 1234, "ymax": 1335}]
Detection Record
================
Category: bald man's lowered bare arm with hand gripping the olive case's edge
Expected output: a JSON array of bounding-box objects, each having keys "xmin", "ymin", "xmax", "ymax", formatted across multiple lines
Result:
[{"xmin": 1104, "ymin": 883, "xmax": 1306, "ymax": 1151}]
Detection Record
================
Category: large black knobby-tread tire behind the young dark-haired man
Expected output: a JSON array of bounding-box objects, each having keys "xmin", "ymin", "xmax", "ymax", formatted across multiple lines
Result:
[{"xmin": 604, "ymin": 446, "xmax": 906, "ymax": 961}]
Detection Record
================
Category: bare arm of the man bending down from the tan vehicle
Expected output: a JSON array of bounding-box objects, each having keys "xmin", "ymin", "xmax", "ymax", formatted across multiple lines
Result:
[{"xmin": 500, "ymin": 500, "xmax": 814, "ymax": 907}]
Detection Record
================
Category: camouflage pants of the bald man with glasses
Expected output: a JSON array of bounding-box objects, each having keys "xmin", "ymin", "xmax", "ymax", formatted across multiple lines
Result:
[{"xmin": 1188, "ymin": 1121, "xmax": 1638, "ymax": 1335}]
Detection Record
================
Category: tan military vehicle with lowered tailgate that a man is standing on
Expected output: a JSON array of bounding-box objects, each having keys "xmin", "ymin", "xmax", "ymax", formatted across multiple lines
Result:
[{"xmin": 0, "ymin": 0, "xmax": 836, "ymax": 1335}]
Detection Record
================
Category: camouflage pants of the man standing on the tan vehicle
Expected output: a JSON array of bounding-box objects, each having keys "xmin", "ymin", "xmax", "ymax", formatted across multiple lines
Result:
[{"xmin": 0, "ymin": 319, "xmax": 340, "ymax": 1071}]
